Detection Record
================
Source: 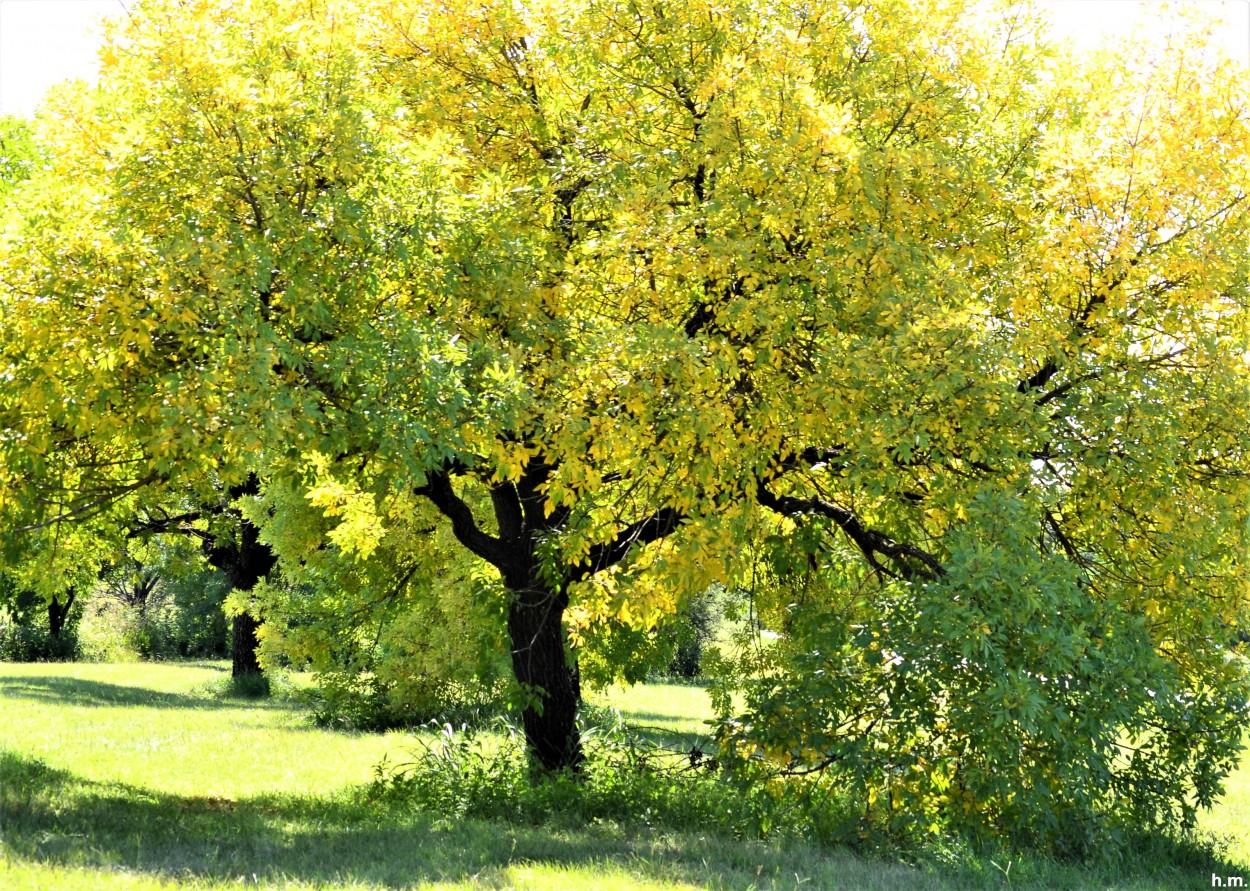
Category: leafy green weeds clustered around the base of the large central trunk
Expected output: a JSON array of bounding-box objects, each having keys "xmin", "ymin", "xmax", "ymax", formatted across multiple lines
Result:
[{"xmin": 366, "ymin": 709, "xmax": 855, "ymax": 844}]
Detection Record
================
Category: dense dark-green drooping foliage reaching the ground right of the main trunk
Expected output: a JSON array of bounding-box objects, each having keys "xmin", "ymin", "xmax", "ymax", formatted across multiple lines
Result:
[{"xmin": 720, "ymin": 496, "xmax": 1250, "ymax": 855}]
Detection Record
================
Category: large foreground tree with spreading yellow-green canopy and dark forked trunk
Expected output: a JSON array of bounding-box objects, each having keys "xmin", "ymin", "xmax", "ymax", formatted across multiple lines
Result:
[{"xmin": 0, "ymin": 0, "xmax": 1250, "ymax": 810}]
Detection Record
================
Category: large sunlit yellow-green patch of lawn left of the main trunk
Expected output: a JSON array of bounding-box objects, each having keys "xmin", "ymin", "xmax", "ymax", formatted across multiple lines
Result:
[{"xmin": 0, "ymin": 662, "xmax": 411, "ymax": 797}]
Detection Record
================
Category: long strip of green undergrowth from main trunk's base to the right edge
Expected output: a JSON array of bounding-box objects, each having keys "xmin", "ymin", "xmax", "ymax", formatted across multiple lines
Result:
[{"xmin": 364, "ymin": 709, "xmax": 1228, "ymax": 880}]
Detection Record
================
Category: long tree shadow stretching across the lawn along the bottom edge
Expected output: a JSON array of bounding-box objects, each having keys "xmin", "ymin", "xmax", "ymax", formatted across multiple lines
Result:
[{"xmin": 0, "ymin": 751, "xmax": 1241, "ymax": 891}]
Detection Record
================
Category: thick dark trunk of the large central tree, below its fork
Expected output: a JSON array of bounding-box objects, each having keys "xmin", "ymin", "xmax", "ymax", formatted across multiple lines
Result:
[{"xmin": 508, "ymin": 586, "xmax": 585, "ymax": 771}]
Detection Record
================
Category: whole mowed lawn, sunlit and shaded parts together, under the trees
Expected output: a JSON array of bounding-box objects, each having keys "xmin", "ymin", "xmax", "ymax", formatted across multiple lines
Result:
[{"xmin": 0, "ymin": 664, "xmax": 1250, "ymax": 891}]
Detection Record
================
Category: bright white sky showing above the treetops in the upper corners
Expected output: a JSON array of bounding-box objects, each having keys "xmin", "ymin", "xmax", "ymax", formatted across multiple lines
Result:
[{"xmin": 0, "ymin": 0, "xmax": 1250, "ymax": 115}]
